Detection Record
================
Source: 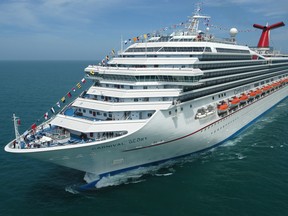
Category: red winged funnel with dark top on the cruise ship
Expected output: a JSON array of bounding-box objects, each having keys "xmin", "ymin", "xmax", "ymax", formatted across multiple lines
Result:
[{"xmin": 253, "ymin": 22, "xmax": 285, "ymax": 48}]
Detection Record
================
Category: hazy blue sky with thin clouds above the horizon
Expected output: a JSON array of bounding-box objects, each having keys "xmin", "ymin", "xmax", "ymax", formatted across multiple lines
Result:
[{"xmin": 0, "ymin": 0, "xmax": 288, "ymax": 60}]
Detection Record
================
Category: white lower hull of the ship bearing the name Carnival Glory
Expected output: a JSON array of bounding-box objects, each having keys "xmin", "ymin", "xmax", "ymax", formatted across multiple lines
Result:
[{"xmin": 6, "ymin": 85, "xmax": 288, "ymax": 186}]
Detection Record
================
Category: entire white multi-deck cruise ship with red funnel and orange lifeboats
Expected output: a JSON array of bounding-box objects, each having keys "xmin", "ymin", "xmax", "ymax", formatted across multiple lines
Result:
[{"xmin": 5, "ymin": 5, "xmax": 288, "ymax": 188}]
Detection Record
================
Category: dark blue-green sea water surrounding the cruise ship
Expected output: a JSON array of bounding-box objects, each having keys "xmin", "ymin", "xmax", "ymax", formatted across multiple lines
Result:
[{"xmin": 0, "ymin": 61, "xmax": 288, "ymax": 216}]
